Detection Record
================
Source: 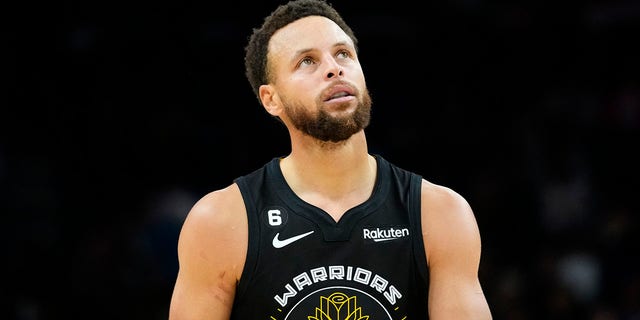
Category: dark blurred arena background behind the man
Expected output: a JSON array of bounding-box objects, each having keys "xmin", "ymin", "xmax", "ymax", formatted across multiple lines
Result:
[{"xmin": 5, "ymin": 0, "xmax": 640, "ymax": 320}]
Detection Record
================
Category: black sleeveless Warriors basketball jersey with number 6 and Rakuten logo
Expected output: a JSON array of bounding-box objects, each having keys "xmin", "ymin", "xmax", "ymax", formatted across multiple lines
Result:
[{"xmin": 231, "ymin": 155, "xmax": 429, "ymax": 320}]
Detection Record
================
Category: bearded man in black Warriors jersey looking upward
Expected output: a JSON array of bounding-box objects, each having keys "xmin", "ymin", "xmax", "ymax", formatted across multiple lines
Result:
[{"xmin": 170, "ymin": 0, "xmax": 491, "ymax": 320}]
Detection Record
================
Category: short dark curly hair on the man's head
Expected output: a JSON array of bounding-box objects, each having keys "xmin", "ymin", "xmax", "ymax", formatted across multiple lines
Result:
[{"xmin": 244, "ymin": 0, "xmax": 358, "ymax": 100}]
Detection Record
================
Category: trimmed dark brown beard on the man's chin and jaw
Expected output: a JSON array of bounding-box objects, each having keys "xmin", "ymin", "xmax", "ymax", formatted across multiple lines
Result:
[{"xmin": 283, "ymin": 89, "xmax": 371, "ymax": 142}]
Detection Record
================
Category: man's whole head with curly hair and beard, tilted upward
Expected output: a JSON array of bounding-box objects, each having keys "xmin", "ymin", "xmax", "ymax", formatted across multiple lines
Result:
[{"xmin": 245, "ymin": 0, "xmax": 371, "ymax": 142}]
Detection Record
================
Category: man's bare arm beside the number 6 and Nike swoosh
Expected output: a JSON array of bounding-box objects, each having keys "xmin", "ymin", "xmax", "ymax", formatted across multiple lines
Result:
[{"xmin": 169, "ymin": 184, "xmax": 248, "ymax": 320}]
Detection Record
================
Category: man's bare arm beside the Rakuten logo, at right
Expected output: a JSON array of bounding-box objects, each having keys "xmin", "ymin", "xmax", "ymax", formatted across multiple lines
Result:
[{"xmin": 422, "ymin": 180, "xmax": 492, "ymax": 320}]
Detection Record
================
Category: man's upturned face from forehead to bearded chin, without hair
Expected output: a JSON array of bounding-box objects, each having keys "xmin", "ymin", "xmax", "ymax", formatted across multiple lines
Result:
[{"xmin": 268, "ymin": 16, "xmax": 371, "ymax": 142}]
